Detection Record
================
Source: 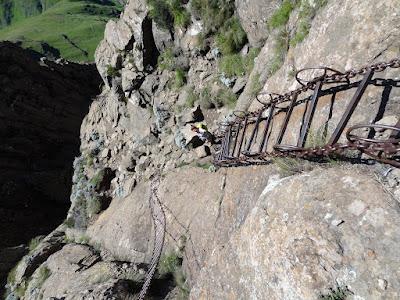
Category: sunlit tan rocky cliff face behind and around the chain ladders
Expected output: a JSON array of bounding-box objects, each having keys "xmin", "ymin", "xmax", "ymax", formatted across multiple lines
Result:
[{"xmin": 4, "ymin": 0, "xmax": 400, "ymax": 300}]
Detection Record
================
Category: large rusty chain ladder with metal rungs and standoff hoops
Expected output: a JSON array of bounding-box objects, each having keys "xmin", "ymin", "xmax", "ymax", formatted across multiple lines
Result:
[{"xmin": 214, "ymin": 58, "xmax": 400, "ymax": 167}]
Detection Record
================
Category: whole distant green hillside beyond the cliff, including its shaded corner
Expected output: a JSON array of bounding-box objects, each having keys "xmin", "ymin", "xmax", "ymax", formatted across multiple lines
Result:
[{"xmin": 0, "ymin": 0, "xmax": 122, "ymax": 62}]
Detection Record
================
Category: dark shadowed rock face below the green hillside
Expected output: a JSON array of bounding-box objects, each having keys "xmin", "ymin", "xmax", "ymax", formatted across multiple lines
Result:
[{"xmin": 0, "ymin": 42, "xmax": 100, "ymax": 288}]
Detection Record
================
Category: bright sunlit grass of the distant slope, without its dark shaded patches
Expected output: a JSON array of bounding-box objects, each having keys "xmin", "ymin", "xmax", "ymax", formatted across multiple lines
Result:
[{"xmin": 0, "ymin": 0, "xmax": 121, "ymax": 61}]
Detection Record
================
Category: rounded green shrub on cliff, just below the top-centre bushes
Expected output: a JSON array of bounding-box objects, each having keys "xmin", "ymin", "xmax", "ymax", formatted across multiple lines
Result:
[{"xmin": 216, "ymin": 17, "xmax": 247, "ymax": 55}]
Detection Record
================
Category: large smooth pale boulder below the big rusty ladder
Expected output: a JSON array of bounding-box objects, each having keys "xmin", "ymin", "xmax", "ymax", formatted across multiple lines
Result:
[{"xmin": 190, "ymin": 168, "xmax": 400, "ymax": 299}]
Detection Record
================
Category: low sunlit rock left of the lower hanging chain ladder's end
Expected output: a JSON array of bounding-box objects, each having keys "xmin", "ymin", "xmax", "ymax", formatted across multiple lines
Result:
[{"xmin": 21, "ymin": 244, "xmax": 144, "ymax": 300}]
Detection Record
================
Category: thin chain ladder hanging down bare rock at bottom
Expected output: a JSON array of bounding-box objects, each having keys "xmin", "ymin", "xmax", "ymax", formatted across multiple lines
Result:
[{"xmin": 139, "ymin": 175, "xmax": 166, "ymax": 300}]
